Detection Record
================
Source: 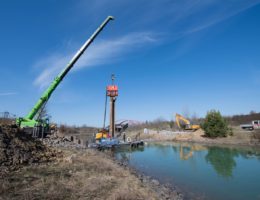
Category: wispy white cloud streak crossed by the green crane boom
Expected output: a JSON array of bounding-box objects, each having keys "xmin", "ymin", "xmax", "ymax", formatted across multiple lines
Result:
[{"xmin": 34, "ymin": 32, "xmax": 158, "ymax": 88}]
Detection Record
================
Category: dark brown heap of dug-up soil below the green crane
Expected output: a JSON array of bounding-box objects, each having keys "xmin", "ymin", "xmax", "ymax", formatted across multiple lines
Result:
[{"xmin": 0, "ymin": 126, "xmax": 57, "ymax": 177}]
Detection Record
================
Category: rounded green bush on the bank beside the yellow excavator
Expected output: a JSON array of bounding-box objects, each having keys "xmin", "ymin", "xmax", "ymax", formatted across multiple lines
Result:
[{"xmin": 202, "ymin": 110, "xmax": 232, "ymax": 138}]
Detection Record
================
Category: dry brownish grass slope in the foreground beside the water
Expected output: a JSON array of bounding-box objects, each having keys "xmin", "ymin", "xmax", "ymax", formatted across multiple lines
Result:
[{"xmin": 0, "ymin": 150, "xmax": 157, "ymax": 199}]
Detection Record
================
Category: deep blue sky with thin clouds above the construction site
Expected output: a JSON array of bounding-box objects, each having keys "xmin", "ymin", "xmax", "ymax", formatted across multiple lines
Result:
[{"xmin": 0, "ymin": 0, "xmax": 260, "ymax": 126}]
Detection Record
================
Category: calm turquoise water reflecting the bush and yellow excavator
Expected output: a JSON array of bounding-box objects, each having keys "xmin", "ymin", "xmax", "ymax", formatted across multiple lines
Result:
[{"xmin": 116, "ymin": 143, "xmax": 260, "ymax": 200}]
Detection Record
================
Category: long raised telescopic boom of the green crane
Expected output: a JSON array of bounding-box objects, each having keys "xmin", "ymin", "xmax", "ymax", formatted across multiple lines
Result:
[{"xmin": 18, "ymin": 16, "xmax": 114, "ymax": 127}]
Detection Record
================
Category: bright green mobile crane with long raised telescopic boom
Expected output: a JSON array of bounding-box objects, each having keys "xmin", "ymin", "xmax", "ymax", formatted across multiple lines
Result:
[{"xmin": 16, "ymin": 16, "xmax": 114, "ymax": 137}]
